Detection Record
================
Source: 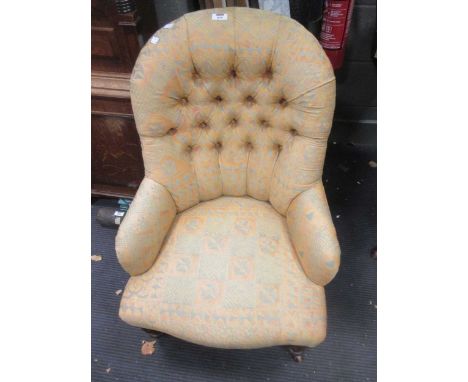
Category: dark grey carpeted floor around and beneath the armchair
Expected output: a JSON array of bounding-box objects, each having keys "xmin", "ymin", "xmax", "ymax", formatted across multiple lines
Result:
[{"xmin": 91, "ymin": 142, "xmax": 377, "ymax": 382}]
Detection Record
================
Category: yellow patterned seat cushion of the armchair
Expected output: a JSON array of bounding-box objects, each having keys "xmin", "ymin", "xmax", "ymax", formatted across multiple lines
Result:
[{"xmin": 120, "ymin": 197, "xmax": 326, "ymax": 348}]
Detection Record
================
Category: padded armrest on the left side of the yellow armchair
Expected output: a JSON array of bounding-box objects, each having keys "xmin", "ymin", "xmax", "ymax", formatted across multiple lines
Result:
[{"xmin": 115, "ymin": 178, "xmax": 176, "ymax": 276}]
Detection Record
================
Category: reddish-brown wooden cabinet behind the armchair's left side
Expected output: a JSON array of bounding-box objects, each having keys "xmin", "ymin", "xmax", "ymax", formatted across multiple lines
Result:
[{"xmin": 91, "ymin": 0, "xmax": 157, "ymax": 197}]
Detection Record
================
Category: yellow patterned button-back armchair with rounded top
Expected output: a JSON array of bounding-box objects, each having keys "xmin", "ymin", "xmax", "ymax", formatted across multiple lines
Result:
[{"xmin": 116, "ymin": 8, "xmax": 340, "ymax": 362}]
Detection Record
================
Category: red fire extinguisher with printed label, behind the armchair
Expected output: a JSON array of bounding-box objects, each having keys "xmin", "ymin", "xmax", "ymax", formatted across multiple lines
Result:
[{"xmin": 320, "ymin": 0, "xmax": 354, "ymax": 70}]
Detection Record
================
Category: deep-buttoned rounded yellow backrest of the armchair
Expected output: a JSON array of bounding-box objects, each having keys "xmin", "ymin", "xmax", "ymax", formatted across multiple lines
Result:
[{"xmin": 131, "ymin": 8, "xmax": 335, "ymax": 215}]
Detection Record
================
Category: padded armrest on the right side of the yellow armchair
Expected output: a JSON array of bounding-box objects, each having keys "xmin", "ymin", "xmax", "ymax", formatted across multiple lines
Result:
[{"xmin": 286, "ymin": 181, "xmax": 340, "ymax": 286}]
